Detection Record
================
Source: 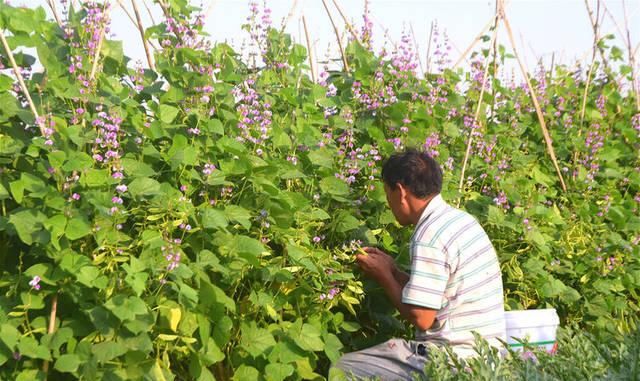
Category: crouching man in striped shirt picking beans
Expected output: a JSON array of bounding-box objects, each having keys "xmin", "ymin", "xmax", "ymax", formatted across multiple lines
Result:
[{"xmin": 332, "ymin": 149, "xmax": 506, "ymax": 380}]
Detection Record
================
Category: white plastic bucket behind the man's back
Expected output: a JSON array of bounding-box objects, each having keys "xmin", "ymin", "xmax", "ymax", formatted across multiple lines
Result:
[{"xmin": 504, "ymin": 308, "xmax": 560, "ymax": 352}]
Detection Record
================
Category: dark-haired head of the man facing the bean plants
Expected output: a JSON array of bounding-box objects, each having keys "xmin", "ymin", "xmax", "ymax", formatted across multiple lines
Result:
[{"xmin": 382, "ymin": 149, "xmax": 442, "ymax": 225}]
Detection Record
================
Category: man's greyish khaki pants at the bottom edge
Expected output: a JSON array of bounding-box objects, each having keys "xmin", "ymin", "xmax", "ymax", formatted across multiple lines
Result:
[{"xmin": 329, "ymin": 339, "xmax": 428, "ymax": 381}]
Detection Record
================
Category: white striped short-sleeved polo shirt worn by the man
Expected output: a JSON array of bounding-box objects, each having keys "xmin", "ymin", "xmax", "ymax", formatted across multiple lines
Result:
[{"xmin": 402, "ymin": 195, "xmax": 506, "ymax": 357}]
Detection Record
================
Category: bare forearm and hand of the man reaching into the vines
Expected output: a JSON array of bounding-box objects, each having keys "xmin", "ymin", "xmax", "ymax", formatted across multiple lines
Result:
[{"xmin": 356, "ymin": 248, "xmax": 437, "ymax": 331}]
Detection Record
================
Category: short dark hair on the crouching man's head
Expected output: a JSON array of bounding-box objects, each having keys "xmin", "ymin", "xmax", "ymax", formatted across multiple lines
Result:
[{"xmin": 382, "ymin": 148, "xmax": 442, "ymax": 198}]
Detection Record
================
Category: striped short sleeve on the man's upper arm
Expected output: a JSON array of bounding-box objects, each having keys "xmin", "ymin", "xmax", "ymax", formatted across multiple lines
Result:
[{"xmin": 402, "ymin": 242, "xmax": 450, "ymax": 310}]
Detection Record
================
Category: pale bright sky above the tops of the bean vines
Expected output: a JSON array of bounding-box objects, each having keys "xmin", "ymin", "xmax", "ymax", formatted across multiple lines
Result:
[{"xmin": 10, "ymin": 0, "xmax": 640, "ymax": 77}]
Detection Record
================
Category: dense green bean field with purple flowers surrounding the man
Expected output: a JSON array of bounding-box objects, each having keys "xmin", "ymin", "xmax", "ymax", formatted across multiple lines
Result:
[{"xmin": 0, "ymin": 0, "xmax": 640, "ymax": 380}]
